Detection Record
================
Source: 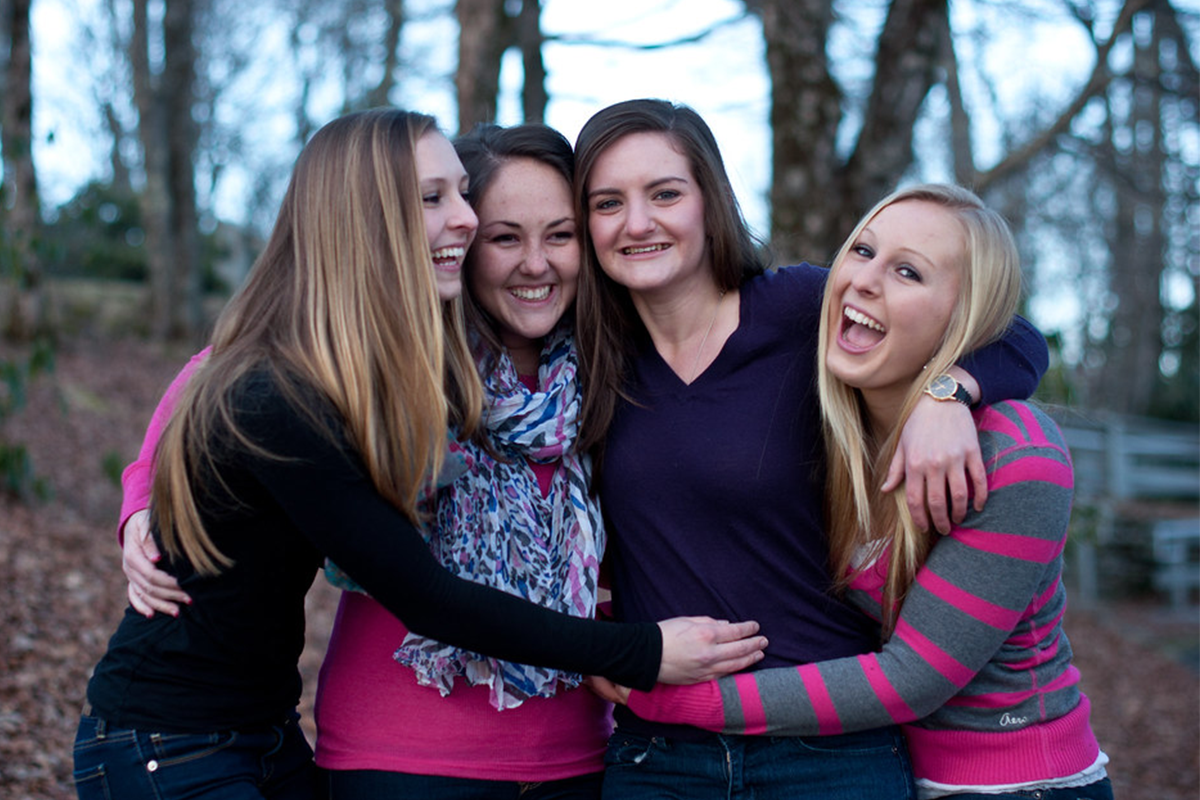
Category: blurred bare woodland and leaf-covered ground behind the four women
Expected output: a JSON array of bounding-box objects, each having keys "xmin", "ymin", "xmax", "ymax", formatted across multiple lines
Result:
[{"xmin": 0, "ymin": 0, "xmax": 1200, "ymax": 800}]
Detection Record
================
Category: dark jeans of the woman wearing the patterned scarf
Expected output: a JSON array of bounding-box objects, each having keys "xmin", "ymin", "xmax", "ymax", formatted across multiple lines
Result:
[{"xmin": 325, "ymin": 770, "xmax": 602, "ymax": 800}]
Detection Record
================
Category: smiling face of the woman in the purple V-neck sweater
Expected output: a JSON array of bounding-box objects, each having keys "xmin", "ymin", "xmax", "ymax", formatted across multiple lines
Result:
[{"xmin": 587, "ymin": 133, "xmax": 713, "ymax": 302}]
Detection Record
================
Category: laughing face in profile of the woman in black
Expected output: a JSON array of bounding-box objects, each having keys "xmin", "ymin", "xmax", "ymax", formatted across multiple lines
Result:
[{"xmin": 416, "ymin": 131, "xmax": 479, "ymax": 300}]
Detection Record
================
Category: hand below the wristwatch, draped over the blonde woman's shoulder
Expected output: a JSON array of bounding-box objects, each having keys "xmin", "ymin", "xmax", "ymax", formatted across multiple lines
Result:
[{"xmin": 882, "ymin": 397, "xmax": 988, "ymax": 534}]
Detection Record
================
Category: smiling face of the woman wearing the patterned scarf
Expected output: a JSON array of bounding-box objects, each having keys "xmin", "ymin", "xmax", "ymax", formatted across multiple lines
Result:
[{"xmin": 467, "ymin": 158, "xmax": 580, "ymax": 374}]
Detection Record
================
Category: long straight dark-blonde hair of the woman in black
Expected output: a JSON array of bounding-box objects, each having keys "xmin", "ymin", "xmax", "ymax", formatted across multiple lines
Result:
[{"xmin": 151, "ymin": 108, "xmax": 482, "ymax": 575}]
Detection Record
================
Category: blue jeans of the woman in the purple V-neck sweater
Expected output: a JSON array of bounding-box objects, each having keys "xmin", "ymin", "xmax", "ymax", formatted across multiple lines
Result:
[{"xmin": 604, "ymin": 728, "xmax": 917, "ymax": 800}]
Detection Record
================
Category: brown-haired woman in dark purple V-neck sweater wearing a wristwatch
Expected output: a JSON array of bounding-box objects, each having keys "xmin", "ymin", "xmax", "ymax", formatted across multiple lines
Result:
[{"xmin": 575, "ymin": 100, "xmax": 1048, "ymax": 800}]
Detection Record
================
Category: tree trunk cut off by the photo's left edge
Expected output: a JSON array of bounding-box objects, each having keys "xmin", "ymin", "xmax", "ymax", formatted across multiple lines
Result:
[{"xmin": 0, "ymin": 0, "xmax": 50, "ymax": 339}]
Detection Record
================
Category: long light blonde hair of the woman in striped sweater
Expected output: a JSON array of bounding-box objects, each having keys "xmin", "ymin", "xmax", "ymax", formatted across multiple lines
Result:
[{"xmin": 817, "ymin": 184, "xmax": 1021, "ymax": 637}]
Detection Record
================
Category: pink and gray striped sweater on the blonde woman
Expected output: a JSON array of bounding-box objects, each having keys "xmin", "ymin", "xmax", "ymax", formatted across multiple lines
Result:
[{"xmin": 629, "ymin": 402, "xmax": 1099, "ymax": 786}]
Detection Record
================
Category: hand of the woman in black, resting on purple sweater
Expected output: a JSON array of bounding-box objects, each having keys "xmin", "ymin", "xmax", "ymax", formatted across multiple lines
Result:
[{"xmin": 659, "ymin": 616, "xmax": 767, "ymax": 684}]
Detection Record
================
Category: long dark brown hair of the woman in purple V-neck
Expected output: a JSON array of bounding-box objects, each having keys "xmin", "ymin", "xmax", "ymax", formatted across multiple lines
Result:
[{"xmin": 575, "ymin": 100, "xmax": 763, "ymax": 475}]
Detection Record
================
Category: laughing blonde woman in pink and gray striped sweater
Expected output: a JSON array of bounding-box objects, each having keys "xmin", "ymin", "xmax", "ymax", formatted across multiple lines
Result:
[{"xmin": 601, "ymin": 185, "xmax": 1112, "ymax": 800}]
